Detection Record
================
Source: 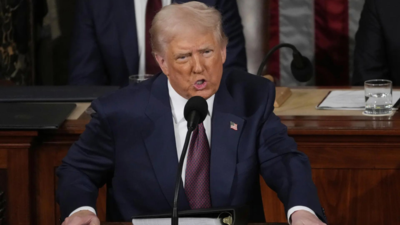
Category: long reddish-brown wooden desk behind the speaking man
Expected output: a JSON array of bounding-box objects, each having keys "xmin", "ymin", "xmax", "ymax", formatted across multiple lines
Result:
[{"xmin": 0, "ymin": 89, "xmax": 400, "ymax": 225}]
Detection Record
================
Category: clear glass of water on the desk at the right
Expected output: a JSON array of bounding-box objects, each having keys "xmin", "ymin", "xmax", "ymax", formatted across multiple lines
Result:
[{"xmin": 364, "ymin": 80, "xmax": 393, "ymax": 115}]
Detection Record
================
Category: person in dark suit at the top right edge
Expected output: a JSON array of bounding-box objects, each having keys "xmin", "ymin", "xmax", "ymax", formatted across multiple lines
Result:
[{"xmin": 352, "ymin": 0, "xmax": 400, "ymax": 86}]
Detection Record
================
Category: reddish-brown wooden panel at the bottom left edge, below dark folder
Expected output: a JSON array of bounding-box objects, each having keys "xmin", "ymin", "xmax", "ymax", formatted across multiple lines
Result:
[{"xmin": 0, "ymin": 131, "xmax": 37, "ymax": 225}]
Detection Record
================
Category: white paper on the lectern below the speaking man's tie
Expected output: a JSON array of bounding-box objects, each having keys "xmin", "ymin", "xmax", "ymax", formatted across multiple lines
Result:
[{"xmin": 132, "ymin": 218, "xmax": 223, "ymax": 225}]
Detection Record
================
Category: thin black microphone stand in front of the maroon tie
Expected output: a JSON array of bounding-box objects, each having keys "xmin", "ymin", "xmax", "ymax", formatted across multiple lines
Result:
[{"xmin": 171, "ymin": 111, "xmax": 199, "ymax": 225}]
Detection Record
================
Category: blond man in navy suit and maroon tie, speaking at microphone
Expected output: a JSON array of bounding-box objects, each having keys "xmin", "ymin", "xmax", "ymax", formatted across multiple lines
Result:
[{"xmin": 57, "ymin": 2, "xmax": 326, "ymax": 225}]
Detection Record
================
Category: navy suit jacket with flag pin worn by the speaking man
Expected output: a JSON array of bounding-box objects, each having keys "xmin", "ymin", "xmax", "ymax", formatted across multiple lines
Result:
[{"xmin": 57, "ymin": 70, "xmax": 325, "ymax": 221}]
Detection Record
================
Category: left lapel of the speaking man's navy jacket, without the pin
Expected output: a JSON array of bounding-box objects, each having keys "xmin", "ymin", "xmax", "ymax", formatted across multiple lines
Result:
[{"xmin": 142, "ymin": 74, "xmax": 190, "ymax": 210}]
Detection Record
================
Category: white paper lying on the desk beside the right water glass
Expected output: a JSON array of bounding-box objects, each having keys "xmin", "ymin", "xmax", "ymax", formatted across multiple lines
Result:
[{"xmin": 316, "ymin": 90, "xmax": 400, "ymax": 110}]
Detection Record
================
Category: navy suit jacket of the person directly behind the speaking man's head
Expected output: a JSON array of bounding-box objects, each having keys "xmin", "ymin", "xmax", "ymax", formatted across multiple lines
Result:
[{"xmin": 69, "ymin": 0, "xmax": 247, "ymax": 86}]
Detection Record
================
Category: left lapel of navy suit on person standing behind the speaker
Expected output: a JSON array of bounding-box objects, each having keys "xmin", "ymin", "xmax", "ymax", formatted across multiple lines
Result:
[{"xmin": 113, "ymin": 0, "xmax": 139, "ymax": 74}]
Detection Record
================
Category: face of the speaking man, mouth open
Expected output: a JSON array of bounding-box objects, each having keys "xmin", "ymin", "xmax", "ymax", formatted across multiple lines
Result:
[{"xmin": 156, "ymin": 29, "xmax": 226, "ymax": 99}]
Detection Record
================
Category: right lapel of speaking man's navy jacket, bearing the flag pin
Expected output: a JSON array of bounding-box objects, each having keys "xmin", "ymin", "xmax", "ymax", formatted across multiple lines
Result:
[{"xmin": 210, "ymin": 75, "xmax": 246, "ymax": 207}]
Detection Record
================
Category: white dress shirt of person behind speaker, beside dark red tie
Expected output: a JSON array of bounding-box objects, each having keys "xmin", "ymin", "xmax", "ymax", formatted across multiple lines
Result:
[{"xmin": 133, "ymin": 0, "xmax": 171, "ymax": 74}]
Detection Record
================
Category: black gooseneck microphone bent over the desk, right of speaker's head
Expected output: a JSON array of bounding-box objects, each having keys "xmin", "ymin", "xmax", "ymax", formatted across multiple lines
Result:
[{"xmin": 257, "ymin": 43, "xmax": 314, "ymax": 82}]
